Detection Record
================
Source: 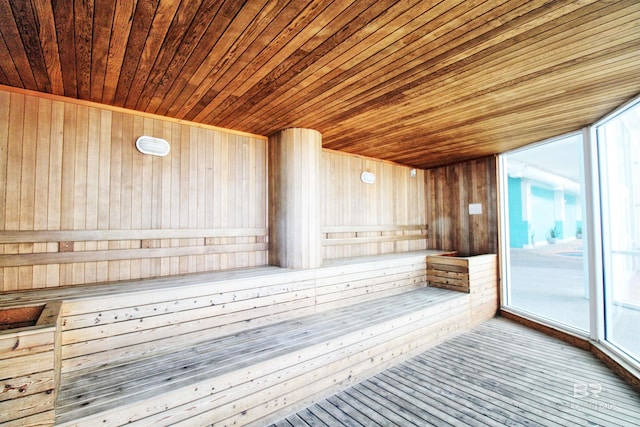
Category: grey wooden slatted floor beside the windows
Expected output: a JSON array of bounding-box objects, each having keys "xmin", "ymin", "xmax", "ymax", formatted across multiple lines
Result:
[{"xmin": 274, "ymin": 318, "xmax": 640, "ymax": 427}]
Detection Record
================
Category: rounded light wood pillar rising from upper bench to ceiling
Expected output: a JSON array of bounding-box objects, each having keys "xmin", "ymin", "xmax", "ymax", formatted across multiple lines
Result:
[{"xmin": 269, "ymin": 128, "xmax": 322, "ymax": 268}]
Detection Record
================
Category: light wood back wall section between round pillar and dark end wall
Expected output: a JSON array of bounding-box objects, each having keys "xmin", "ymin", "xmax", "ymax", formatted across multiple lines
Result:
[{"xmin": 320, "ymin": 150, "xmax": 427, "ymax": 259}]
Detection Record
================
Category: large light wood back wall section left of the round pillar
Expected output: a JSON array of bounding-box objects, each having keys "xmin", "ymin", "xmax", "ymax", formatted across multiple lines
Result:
[{"xmin": 0, "ymin": 90, "xmax": 267, "ymax": 291}]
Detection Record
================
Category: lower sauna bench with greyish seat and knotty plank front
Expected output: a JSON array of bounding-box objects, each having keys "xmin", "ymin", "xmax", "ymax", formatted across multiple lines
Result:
[{"xmin": 56, "ymin": 287, "xmax": 470, "ymax": 426}]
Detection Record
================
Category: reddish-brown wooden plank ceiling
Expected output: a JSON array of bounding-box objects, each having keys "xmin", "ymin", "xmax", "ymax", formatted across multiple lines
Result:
[{"xmin": 0, "ymin": 0, "xmax": 640, "ymax": 168}]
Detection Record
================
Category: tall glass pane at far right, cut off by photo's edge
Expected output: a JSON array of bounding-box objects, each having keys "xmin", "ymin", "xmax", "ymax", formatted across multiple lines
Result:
[{"xmin": 596, "ymin": 104, "xmax": 640, "ymax": 361}]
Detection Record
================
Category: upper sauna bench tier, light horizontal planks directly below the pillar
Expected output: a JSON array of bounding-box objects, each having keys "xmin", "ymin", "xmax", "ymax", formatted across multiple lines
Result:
[{"xmin": 53, "ymin": 252, "xmax": 440, "ymax": 372}]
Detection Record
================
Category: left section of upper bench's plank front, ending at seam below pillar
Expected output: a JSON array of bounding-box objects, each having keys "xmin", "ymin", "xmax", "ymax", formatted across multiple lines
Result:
[{"xmin": 62, "ymin": 268, "xmax": 315, "ymax": 373}]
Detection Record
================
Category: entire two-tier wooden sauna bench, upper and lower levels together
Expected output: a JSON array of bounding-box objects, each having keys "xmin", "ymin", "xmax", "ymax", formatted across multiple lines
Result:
[{"xmin": 0, "ymin": 251, "xmax": 497, "ymax": 426}]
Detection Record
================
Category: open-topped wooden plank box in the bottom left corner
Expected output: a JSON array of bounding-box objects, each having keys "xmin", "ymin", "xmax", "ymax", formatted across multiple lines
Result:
[{"xmin": 0, "ymin": 302, "xmax": 61, "ymax": 426}]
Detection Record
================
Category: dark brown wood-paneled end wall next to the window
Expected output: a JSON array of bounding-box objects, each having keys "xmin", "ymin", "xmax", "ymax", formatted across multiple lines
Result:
[{"xmin": 425, "ymin": 156, "xmax": 498, "ymax": 256}]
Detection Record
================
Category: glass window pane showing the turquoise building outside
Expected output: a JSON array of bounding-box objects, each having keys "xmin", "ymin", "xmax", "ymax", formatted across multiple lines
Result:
[{"xmin": 502, "ymin": 134, "xmax": 589, "ymax": 332}]
